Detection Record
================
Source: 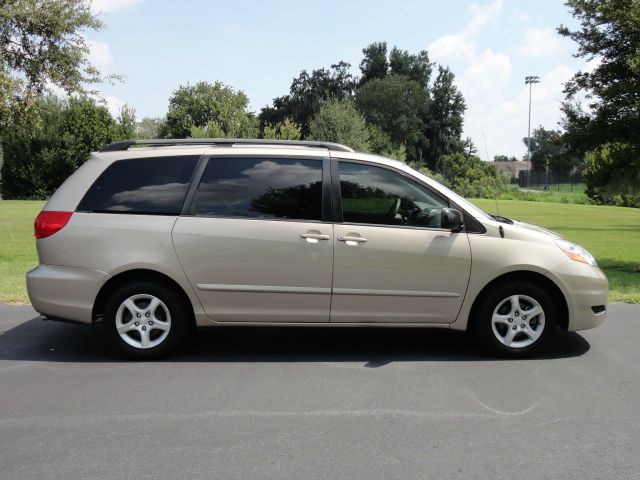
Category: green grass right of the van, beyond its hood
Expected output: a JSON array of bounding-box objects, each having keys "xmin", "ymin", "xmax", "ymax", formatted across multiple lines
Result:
[{"xmin": 473, "ymin": 199, "xmax": 640, "ymax": 303}]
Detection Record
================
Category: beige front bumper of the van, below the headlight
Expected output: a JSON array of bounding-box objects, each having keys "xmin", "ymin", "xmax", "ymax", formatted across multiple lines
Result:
[{"xmin": 547, "ymin": 260, "xmax": 609, "ymax": 332}]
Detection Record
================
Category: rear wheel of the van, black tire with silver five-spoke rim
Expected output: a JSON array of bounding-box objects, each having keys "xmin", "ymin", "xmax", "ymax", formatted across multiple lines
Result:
[{"xmin": 103, "ymin": 281, "xmax": 191, "ymax": 360}]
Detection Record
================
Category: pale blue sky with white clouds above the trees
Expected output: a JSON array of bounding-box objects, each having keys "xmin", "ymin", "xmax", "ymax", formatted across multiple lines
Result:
[{"xmin": 86, "ymin": 0, "xmax": 593, "ymax": 160}]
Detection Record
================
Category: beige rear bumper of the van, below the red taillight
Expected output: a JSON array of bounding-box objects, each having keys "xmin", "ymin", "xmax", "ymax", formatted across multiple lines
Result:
[{"xmin": 27, "ymin": 265, "xmax": 109, "ymax": 323}]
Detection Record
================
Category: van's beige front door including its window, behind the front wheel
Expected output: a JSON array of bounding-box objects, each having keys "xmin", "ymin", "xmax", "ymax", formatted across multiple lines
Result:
[{"xmin": 331, "ymin": 161, "xmax": 471, "ymax": 324}]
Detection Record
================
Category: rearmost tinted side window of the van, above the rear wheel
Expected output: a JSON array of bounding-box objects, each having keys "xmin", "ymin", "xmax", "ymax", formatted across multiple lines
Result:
[{"xmin": 78, "ymin": 155, "xmax": 198, "ymax": 215}]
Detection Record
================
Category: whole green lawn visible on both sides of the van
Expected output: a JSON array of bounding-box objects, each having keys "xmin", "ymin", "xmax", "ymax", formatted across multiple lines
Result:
[{"xmin": 0, "ymin": 200, "xmax": 640, "ymax": 303}]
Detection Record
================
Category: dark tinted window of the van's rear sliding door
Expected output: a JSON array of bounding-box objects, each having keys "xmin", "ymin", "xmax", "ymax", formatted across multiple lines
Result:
[{"xmin": 196, "ymin": 158, "xmax": 322, "ymax": 220}]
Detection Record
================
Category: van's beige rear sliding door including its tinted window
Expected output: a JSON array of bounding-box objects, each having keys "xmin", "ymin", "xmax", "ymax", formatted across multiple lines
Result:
[{"xmin": 173, "ymin": 156, "xmax": 334, "ymax": 322}]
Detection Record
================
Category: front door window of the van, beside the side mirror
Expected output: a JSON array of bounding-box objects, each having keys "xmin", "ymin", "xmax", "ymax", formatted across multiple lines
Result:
[{"xmin": 339, "ymin": 162, "xmax": 448, "ymax": 227}]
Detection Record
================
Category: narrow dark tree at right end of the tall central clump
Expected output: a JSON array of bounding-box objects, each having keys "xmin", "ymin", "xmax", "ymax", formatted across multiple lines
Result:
[{"xmin": 425, "ymin": 67, "xmax": 467, "ymax": 168}]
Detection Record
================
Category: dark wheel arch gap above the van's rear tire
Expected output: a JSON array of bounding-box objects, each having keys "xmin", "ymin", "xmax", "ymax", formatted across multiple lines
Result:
[{"xmin": 92, "ymin": 268, "xmax": 195, "ymax": 327}]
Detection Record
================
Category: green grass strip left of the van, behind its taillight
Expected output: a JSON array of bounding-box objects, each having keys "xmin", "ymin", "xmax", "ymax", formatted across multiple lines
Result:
[{"xmin": 0, "ymin": 200, "xmax": 44, "ymax": 303}]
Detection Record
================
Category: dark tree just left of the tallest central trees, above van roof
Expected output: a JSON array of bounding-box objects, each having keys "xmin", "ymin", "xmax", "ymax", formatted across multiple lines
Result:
[{"xmin": 259, "ymin": 62, "xmax": 355, "ymax": 139}]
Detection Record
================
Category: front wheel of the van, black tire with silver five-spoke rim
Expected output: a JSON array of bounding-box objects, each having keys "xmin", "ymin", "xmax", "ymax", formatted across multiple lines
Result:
[{"xmin": 470, "ymin": 282, "xmax": 559, "ymax": 358}]
